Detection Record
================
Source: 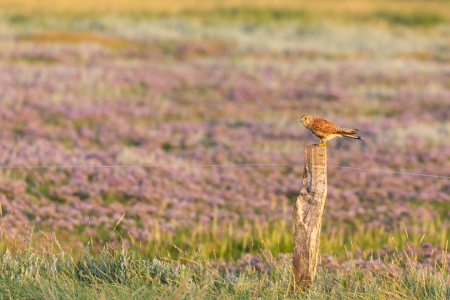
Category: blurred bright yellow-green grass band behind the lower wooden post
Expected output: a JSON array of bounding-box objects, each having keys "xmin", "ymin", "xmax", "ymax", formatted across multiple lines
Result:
[{"xmin": 133, "ymin": 220, "xmax": 447, "ymax": 261}]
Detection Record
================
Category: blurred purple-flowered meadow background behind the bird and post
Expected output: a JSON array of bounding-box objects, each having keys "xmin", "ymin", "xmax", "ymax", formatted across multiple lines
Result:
[{"xmin": 0, "ymin": 0, "xmax": 450, "ymax": 262}]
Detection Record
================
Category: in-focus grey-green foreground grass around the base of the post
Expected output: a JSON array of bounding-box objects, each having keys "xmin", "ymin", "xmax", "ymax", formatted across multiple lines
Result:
[{"xmin": 0, "ymin": 229, "xmax": 450, "ymax": 299}]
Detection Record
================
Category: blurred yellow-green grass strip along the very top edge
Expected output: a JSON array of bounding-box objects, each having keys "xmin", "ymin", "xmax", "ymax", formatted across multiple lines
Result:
[{"xmin": 0, "ymin": 0, "xmax": 450, "ymax": 26}]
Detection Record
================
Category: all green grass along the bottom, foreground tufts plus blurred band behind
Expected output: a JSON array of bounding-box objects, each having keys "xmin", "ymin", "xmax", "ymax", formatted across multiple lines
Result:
[{"xmin": 0, "ymin": 207, "xmax": 450, "ymax": 299}]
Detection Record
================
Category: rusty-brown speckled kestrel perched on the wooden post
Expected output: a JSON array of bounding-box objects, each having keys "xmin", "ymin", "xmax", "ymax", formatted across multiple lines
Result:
[{"xmin": 300, "ymin": 115, "xmax": 363, "ymax": 146}]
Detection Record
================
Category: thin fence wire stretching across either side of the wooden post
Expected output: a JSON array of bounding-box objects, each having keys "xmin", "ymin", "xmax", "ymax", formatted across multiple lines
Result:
[{"xmin": 0, "ymin": 164, "xmax": 450, "ymax": 179}]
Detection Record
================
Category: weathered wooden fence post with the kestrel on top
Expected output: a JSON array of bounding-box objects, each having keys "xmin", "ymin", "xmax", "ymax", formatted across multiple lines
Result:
[{"xmin": 292, "ymin": 145, "xmax": 327, "ymax": 290}]
